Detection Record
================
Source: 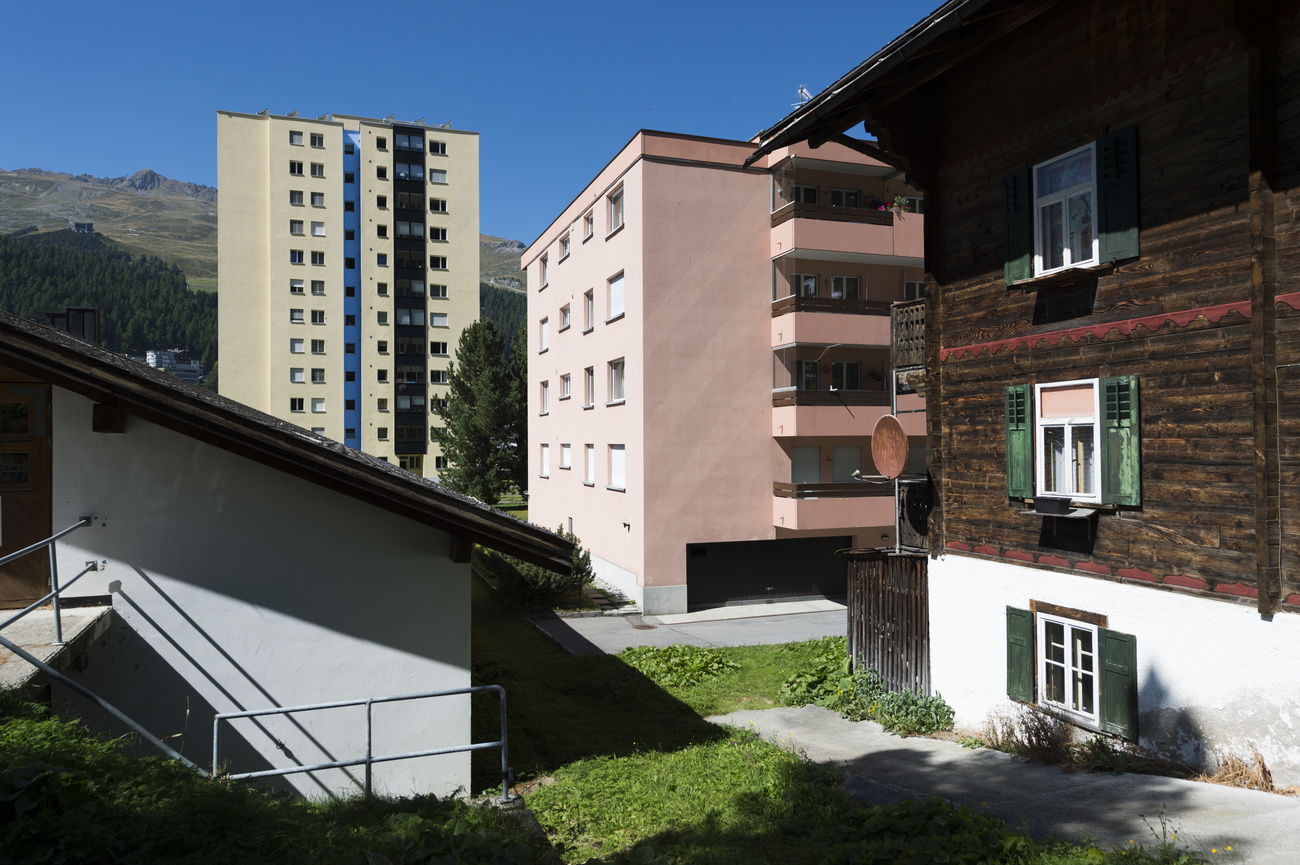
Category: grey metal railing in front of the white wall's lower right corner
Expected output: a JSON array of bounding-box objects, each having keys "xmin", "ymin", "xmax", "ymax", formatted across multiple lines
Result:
[{"xmin": 212, "ymin": 684, "xmax": 514, "ymax": 803}]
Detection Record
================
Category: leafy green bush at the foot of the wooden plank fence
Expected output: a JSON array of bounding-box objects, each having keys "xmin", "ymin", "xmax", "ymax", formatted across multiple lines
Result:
[{"xmin": 781, "ymin": 637, "xmax": 954, "ymax": 736}]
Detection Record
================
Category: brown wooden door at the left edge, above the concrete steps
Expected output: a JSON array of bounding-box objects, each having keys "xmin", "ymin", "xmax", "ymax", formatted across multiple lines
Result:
[{"xmin": 0, "ymin": 369, "xmax": 52, "ymax": 607}]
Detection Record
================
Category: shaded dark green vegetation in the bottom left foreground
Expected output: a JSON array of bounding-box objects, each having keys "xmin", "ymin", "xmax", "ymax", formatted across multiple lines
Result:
[{"xmin": 0, "ymin": 692, "xmax": 537, "ymax": 865}]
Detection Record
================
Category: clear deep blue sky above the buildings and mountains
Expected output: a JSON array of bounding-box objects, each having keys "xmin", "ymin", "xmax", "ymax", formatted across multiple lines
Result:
[{"xmin": 0, "ymin": 0, "xmax": 940, "ymax": 242}]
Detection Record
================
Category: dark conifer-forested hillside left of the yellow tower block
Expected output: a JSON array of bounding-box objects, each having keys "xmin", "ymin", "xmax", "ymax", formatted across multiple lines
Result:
[{"xmin": 0, "ymin": 229, "xmax": 217, "ymax": 369}]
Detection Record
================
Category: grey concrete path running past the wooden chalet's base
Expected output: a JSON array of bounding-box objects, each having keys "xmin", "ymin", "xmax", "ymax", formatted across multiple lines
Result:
[{"xmin": 709, "ymin": 706, "xmax": 1300, "ymax": 865}]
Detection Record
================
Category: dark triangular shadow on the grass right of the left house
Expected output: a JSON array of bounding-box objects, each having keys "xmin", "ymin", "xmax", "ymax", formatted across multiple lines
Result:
[{"xmin": 472, "ymin": 580, "xmax": 727, "ymax": 792}]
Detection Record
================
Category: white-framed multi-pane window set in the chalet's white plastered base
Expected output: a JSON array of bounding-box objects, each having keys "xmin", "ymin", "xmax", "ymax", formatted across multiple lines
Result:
[{"xmin": 1036, "ymin": 611, "xmax": 1101, "ymax": 726}]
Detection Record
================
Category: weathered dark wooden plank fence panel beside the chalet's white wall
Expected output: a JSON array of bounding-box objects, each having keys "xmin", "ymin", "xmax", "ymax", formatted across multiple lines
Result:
[{"xmin": 849, "ymin": 553, "xmax": 930, "ymax": 695}]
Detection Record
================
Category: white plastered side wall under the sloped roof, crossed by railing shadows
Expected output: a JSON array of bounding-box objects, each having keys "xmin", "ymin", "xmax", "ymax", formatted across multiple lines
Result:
[{"xmin": 53, "ymin": 388, "xmax": 471, "ymax": 796}]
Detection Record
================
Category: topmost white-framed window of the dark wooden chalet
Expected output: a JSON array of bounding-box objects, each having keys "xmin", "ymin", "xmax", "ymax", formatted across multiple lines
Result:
[{"xmin": 1034, "ymin": 142, "xmax": 1101, "ymax": 276}]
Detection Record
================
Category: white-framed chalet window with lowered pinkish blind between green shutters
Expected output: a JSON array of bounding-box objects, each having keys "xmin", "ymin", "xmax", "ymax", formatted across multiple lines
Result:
[{"xmin": 1034, "ymin": 379, "xmax": 1101, "ymax": 502}]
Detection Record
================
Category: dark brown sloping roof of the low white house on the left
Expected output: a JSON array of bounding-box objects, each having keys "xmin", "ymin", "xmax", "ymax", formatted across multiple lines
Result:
[{"xmin": 0, "ymin": 312, "xmax": 573, "ymax": 572}]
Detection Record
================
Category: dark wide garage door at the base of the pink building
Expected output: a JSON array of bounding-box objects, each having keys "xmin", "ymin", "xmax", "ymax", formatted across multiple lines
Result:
[{"xmin": 686, "ymin": 537, "xmax": 853, "ymax": 610}]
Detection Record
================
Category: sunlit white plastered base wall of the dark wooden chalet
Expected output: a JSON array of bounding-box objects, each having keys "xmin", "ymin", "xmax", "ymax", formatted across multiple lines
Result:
[{"xmin": 930, "ymin": 555, "xmax": 1300, "ymax": 786}]
